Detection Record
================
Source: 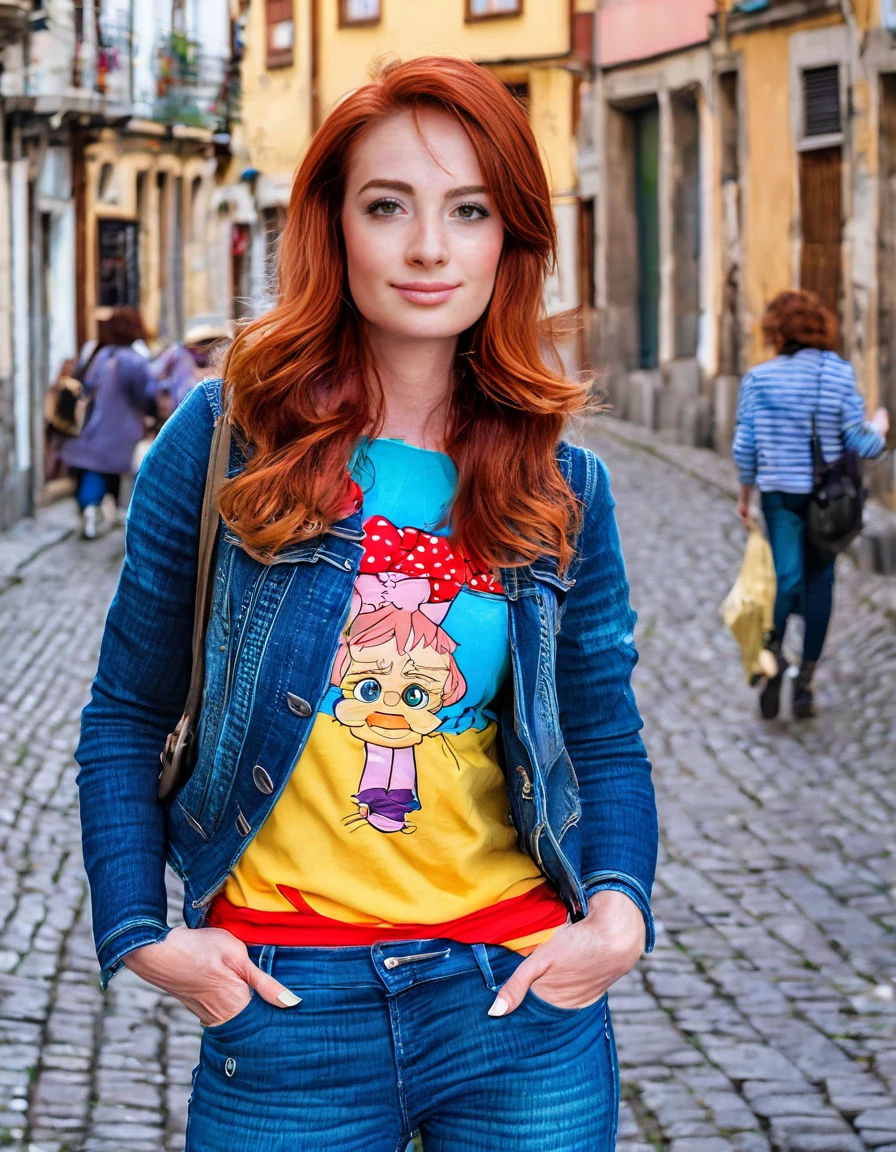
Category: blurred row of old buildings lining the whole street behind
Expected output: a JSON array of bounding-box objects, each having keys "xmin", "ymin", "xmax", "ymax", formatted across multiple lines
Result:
[{"xmin": 0, "ymin": 0, "xmax": 896, "ymax": 555}]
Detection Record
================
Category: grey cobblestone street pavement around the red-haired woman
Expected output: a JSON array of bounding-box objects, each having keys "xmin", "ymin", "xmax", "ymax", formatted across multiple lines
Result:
[{"xmin": 0, "ymin": 433, "xmax": 896, "ymax": 1152}]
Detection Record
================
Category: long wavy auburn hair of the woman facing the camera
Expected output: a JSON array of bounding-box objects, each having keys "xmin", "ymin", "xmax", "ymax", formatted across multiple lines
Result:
[{"xmin": 220, "ymin": 56, "xmax": 589, "ymax": 568}]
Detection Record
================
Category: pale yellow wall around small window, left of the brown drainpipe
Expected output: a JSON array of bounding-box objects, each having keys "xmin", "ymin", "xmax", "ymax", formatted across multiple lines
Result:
[{"xmin": 241, "ymin": 0, "xmax": 313, "ymax": 174}]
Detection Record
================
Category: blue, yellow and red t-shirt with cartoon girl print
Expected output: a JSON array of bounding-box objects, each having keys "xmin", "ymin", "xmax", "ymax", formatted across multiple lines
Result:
[{"xmin": 208, "ymin": 439, "xmax": 567, "ymax": 950}]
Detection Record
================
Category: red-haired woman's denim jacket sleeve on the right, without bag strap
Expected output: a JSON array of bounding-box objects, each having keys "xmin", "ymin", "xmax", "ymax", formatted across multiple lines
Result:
[{"xmin": 556, "ymin": 453, "xmax": 658, "ymax": 952}]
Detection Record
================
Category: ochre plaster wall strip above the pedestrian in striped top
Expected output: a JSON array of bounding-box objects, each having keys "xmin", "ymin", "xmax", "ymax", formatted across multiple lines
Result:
[{"xmin": 731, "ymin": 14, "xmax": 841, "ymax": 363}]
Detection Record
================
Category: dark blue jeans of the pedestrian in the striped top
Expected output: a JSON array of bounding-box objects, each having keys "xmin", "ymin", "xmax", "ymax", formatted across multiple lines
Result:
[{"xmin": 762, "ymin": 492, "xmax": 836, "ymax": 662}]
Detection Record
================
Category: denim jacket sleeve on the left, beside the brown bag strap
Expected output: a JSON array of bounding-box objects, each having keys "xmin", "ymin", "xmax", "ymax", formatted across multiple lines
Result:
[{"xmin": 75, "ymin": 388, "xmax": 214, "ymax": 987}]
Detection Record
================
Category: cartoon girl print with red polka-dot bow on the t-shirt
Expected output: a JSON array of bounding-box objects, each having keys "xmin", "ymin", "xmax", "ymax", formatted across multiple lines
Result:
[{"xmin": 332, "ymin": 516, "xmax": 501, "ymax": 834}]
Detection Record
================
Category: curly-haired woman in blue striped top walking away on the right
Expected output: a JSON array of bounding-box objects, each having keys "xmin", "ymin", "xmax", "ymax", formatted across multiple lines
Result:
[{"xmin": 734, "ymin": 291, "xmax": 889, "ymax": 720}]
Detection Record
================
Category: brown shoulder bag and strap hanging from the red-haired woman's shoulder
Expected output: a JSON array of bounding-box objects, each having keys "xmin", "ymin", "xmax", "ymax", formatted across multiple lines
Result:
[{"xmin": 159, "ymin": 415, "xmax": 230, "ymax": 804}]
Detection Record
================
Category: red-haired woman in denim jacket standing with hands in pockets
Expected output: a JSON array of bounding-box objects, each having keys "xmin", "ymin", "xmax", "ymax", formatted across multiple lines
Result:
[{"xmin": 78, "ymin": 58, "xmax": 656, "ymax": 1152}]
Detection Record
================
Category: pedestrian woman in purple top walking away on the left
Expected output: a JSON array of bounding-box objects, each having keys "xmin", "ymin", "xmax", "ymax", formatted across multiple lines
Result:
[{"xmin": 60, "ymin": 308, "xmax": 150, "ymax": 540}]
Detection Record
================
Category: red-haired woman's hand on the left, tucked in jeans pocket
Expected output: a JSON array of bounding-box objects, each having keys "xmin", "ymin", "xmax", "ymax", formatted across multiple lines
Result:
[{"xmin": 118, "ymin": 927, "xmax": 302, "ymax": 1024}]
